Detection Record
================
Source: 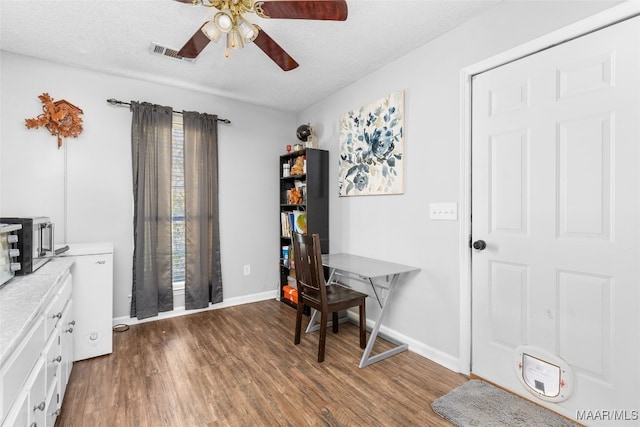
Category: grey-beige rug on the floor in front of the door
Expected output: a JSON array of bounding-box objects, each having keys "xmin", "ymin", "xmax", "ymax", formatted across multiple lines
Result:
[{"xmin": 431, "ymin": 380, "xmax": 579, "ymax": 427}]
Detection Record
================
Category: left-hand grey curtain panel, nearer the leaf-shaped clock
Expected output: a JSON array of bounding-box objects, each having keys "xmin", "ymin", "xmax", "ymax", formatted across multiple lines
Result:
[{"xmin": 131, "ymin": 102, "xmax": 173, "ymax": 319}]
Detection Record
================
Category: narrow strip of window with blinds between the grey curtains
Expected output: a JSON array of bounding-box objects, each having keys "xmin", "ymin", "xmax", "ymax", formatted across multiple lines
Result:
[{"xmin": 171, "ymin": 114, "xmax": 185, "ymax": 290}]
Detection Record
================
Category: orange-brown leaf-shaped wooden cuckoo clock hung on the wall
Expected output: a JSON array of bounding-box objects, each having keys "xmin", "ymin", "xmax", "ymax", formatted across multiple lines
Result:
[{"xmin": 25, "ymin": 93, "xmax": 82, "ymax": 148}]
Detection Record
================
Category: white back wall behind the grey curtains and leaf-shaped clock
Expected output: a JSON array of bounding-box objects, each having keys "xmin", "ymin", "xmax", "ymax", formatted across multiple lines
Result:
[{"xmin": 0, "ymin": 52, "xmax": 296, "ymax": 318}]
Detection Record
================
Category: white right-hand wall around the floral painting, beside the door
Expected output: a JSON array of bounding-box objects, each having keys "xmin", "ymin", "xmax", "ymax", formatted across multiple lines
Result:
[{"xmin": 298, "ymin": 1, "xmax": 616, "ymax": 372}]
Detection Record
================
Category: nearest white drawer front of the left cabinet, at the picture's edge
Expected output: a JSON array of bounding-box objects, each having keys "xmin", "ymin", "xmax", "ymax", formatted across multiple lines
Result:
[{"xmin": 0, "ymin": 316, "xmax": 44, "ymax": 422}]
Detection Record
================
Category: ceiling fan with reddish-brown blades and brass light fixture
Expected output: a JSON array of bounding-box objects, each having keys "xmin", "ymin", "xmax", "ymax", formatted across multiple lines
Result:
[{"xmin": 176, "ymin": 0, "xmax": 347, "ymax": 71}]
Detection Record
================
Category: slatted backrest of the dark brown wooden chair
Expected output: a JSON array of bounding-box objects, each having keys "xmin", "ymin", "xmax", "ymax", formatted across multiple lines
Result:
[{"xmin": 292, "ymin": 233, "xmax": 327, "ymax": 308}]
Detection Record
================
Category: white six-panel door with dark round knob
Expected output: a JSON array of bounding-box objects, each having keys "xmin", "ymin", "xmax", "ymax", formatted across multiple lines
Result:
[{"xmin": 472, "ymin": 18, "xmax": 640, "ymax": 425}]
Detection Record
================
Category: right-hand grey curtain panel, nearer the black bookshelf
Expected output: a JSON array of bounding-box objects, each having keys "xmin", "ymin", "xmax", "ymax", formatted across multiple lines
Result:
[{"xmin": 183, "ymin": 111, "xmax": 222, "ymax": 309}]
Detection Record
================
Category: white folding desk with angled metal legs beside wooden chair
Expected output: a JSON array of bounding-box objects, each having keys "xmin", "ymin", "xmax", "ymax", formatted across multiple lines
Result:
[{"xmin": 307, "ymin": 254, "xmax": 420, "ymax": 368}]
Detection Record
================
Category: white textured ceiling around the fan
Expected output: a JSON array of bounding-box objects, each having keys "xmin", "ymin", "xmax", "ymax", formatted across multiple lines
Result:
[{"xmin": 0, "ymin": 0, "xmax": 499, "ymax": 112}]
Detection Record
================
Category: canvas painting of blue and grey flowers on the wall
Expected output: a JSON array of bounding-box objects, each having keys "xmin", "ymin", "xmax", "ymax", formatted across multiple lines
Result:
[{"xmin": 338, "ymin": 91, "xmax": 404, "ymax": 196}]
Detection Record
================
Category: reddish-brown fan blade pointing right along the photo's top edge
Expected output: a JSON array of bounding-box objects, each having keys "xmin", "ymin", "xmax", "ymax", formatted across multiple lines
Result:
[{"xmin": 256, "ymin": 0, "xmax": 348, "ymax": 21}]
